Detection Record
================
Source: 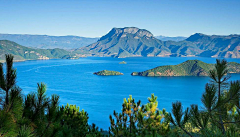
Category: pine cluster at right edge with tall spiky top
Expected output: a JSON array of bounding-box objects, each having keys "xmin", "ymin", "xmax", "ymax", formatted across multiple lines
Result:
[{"xmin": 170, "ymin": 60, "xmax": 240, "ymax": 137}]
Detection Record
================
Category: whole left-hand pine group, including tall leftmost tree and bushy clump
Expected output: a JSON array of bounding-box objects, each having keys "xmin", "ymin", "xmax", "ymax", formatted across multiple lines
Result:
[{"xmin": 0, "ymin": 55, "xmax": 103, "ymax": 137}]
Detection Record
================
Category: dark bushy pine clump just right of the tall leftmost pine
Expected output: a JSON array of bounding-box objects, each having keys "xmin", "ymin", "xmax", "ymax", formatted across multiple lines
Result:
[{"xmin": 19, "ymin": 83, "xmax": 101, "ymax": 137}]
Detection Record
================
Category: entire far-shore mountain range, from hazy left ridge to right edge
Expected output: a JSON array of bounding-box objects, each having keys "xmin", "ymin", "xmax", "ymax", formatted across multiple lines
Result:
[{"xmin": 0, "ymin": 27, "xmax": 240, "ymax": 58}]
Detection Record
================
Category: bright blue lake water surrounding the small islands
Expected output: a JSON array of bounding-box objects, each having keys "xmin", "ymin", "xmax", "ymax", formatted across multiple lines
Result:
[{"xmin": 14, "ymin": 57, "xmax": 240, "ymax": 129}]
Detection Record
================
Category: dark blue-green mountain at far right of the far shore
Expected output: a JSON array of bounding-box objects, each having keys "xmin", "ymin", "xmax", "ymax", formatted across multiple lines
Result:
[{"xmin": 186, "ymin": 33, "xmax": 240, "ymax": 58}]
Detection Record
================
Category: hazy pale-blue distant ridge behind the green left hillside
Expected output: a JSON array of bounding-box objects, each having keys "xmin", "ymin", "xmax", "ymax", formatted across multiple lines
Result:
[{"xmin": 0, "ymin": 34, "xmax": 98, "ymax": 49}]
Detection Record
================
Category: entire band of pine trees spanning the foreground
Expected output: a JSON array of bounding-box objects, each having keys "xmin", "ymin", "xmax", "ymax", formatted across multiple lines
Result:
[{"xmin": 0, "ymin": 55, "xmax": 240, "ymax": 137}]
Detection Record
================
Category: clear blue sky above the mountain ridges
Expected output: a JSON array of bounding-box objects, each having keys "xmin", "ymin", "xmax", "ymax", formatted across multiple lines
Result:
[{"xmin": 0, "ymin": 0, "xmax": 240, "ymax": 37}]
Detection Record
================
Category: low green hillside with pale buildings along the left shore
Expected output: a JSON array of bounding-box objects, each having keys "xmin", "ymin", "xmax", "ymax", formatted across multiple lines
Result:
[{"xmin": 0, "ymin": 40, "xmax": 78, "ymax": 62}]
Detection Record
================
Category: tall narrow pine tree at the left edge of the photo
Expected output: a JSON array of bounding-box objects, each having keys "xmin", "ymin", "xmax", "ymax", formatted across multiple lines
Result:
[{"xmin": 0, "ymin": 54, "xmax": 23, "ymax": 136}]
